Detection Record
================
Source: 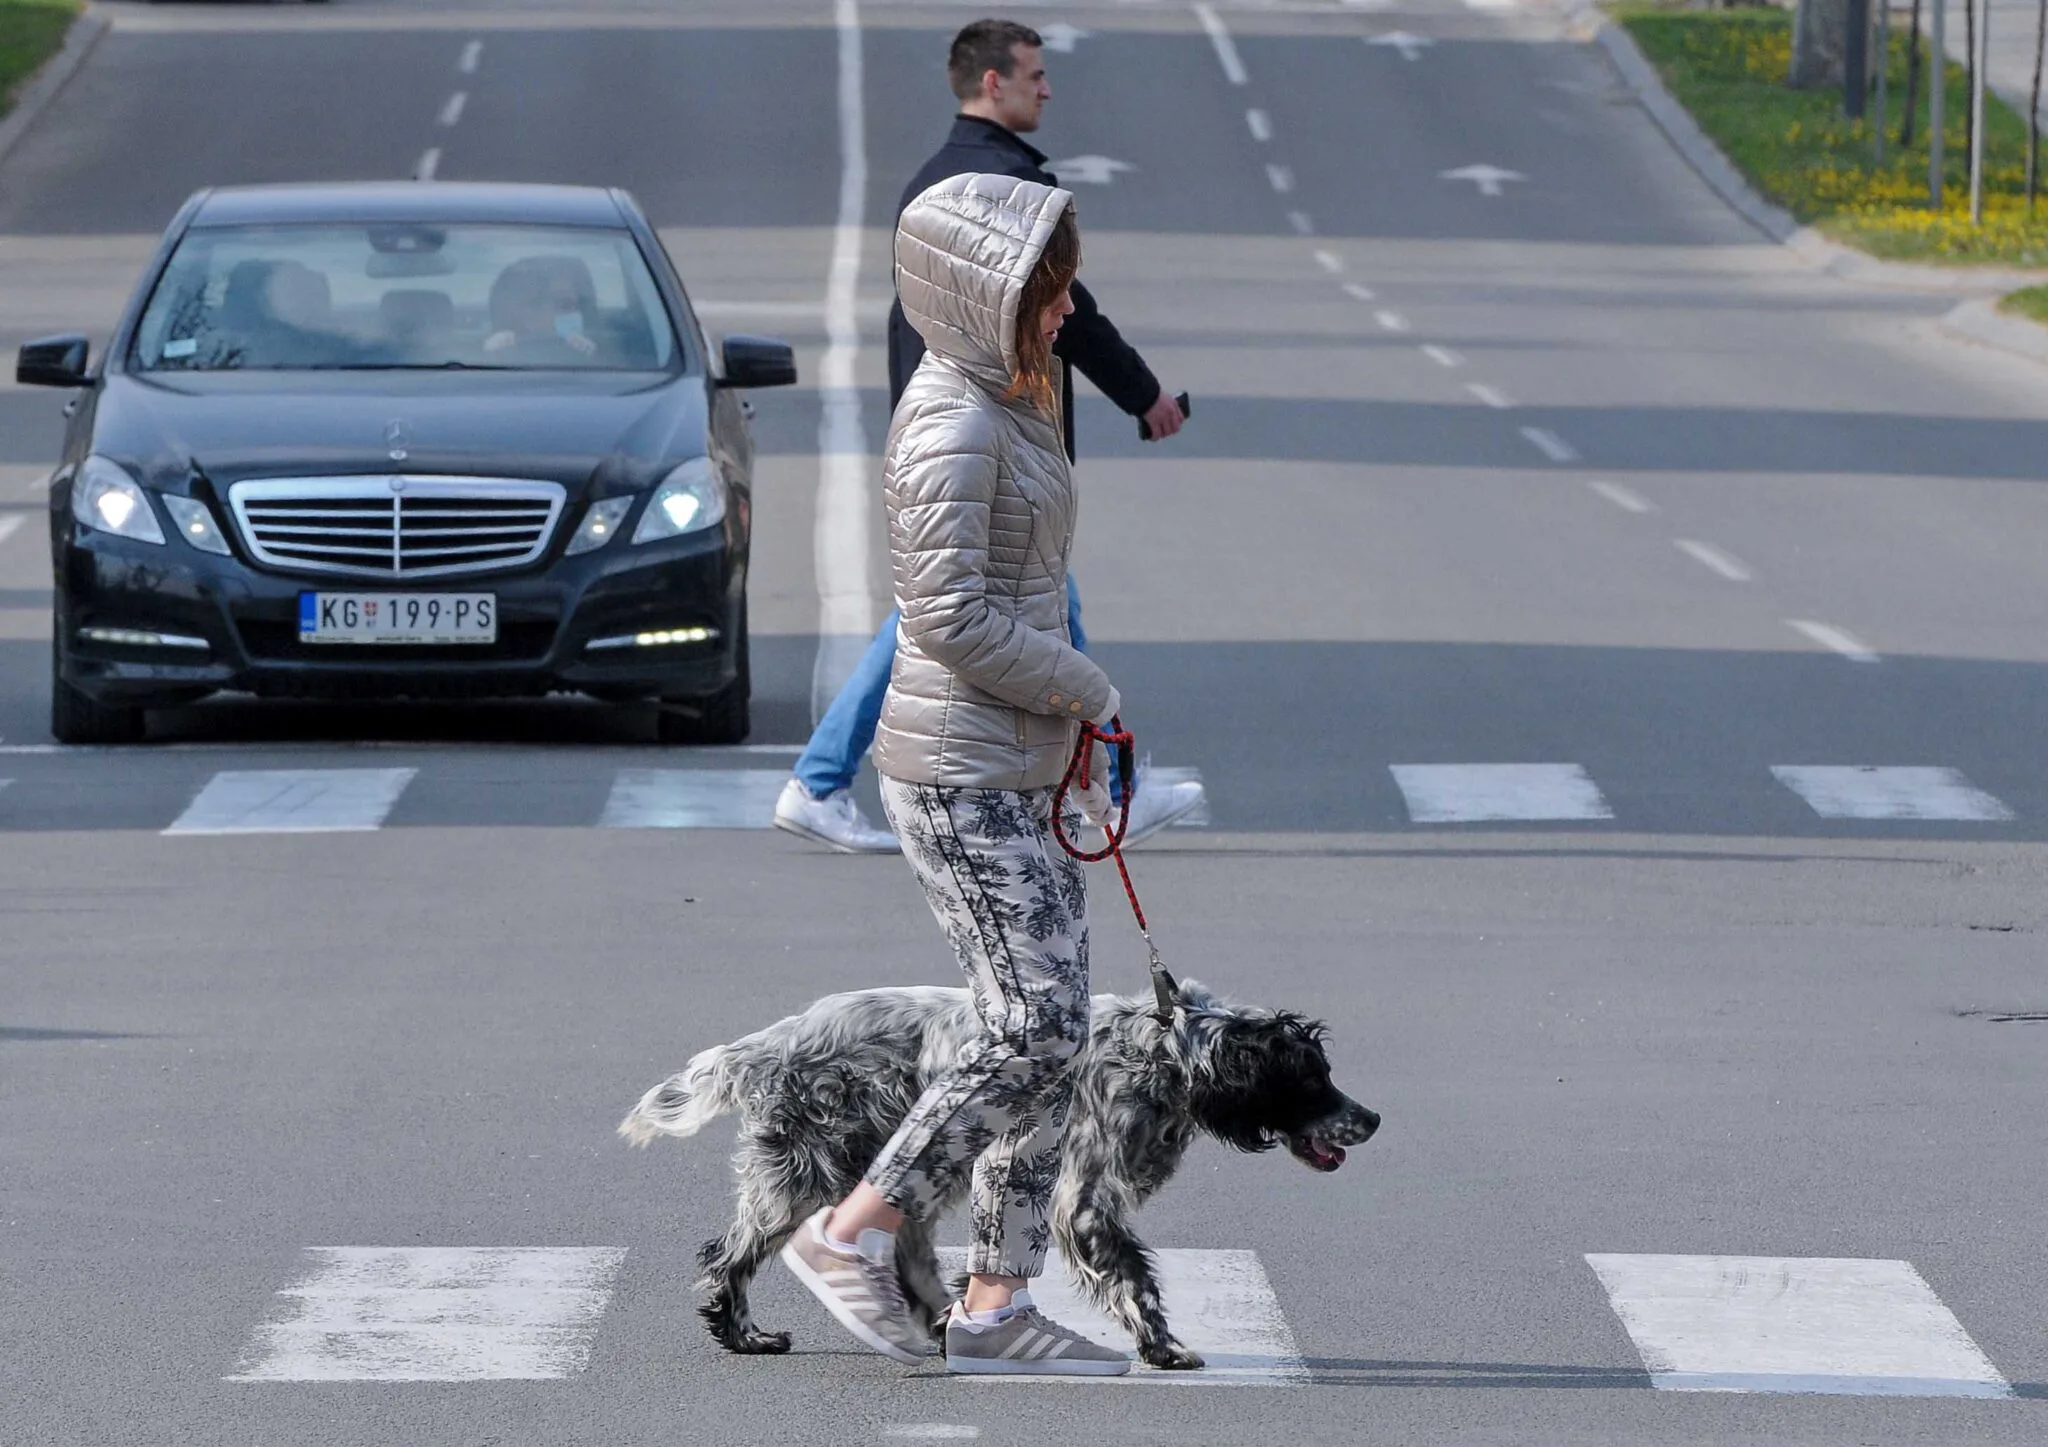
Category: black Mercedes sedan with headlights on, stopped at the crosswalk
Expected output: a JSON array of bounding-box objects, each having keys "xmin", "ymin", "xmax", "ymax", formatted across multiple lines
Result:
[{"xmin": 16, "ymin": 182, "xmax": 797, "ymax": 743}]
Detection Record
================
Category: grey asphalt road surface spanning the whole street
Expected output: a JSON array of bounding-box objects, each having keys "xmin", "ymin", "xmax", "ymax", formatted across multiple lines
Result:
[{"xmin": 0, "ymin": 0, "xmax": 2048, "ymax": 1447}]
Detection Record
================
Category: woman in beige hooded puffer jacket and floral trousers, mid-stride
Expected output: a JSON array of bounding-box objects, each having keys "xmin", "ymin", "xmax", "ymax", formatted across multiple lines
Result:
[{"xmin": 782, "ymin": 174, "xmax": 1130, "ymax": 1375}]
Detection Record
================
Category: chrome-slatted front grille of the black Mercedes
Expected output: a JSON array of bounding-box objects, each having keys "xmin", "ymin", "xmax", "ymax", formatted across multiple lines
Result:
[{"xmin": 227, "ymin": 477, "xmax": 567, "ymax": 579}]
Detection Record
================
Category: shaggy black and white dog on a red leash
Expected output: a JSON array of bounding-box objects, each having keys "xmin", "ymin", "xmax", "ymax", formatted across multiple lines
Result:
[{"xmin": 618, "ymin": 980, "xmax": 1380, "ymax": 1367}]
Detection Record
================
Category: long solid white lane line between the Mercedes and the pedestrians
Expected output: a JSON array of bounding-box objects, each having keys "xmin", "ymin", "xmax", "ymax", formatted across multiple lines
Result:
[{"xmin": 811, "ymin": 0, "xmax": 874, "ymax": 722}]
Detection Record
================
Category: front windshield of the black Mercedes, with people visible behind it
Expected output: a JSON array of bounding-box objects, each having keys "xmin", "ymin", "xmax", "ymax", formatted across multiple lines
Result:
[{"xmin": 131, "ymin": 223, "xmax": 680, "ymax": 372}]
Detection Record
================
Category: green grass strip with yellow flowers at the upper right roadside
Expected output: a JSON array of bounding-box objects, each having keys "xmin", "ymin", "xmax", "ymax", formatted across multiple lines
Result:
[{"xmin": 1612, "ymin": 2, "xmax": 2048, "ymax": 266}]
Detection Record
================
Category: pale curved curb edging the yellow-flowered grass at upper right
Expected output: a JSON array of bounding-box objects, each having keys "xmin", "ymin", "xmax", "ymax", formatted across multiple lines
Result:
[{"xmin": 1559, "ymin": 0, "xmax": 2048, "ymax": 296}]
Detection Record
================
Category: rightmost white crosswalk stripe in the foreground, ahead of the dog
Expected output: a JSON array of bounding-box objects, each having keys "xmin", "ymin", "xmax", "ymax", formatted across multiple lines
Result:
[{"xmin": 1585, "ymin": 1255, "xmax": 2013, "ymax": 1398}]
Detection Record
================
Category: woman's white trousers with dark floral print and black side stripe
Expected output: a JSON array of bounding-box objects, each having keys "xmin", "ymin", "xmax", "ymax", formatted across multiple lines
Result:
[{"xmin": 868, "ymin": 776, "xmax": 1087, "ymax": 1277}]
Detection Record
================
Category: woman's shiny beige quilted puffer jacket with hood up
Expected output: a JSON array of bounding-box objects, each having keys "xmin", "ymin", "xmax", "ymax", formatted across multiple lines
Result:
[{"xmin": 874, "ymin": 176, "xmax": 1116, "ymax": 790}]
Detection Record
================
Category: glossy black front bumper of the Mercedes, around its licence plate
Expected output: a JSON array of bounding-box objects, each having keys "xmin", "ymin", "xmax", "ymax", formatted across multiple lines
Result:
[{"xmin": 55, "ymin": 524, "xmax": 745, "ymax": 704}]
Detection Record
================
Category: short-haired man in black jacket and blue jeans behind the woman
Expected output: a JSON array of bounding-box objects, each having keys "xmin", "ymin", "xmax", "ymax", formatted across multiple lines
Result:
[{"xmin": 774, "ymin": 20, "xmax": 1204, "ymax": 853}]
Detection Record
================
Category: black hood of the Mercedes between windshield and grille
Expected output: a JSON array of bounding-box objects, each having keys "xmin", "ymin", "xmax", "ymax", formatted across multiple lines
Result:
[{"xmin": 92, "ymin": 372, "xmax": 707, "ymax": 491}]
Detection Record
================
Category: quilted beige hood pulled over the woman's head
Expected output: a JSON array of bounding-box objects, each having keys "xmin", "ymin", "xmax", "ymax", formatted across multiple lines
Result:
[{"xmin": 895, "ymin": 174, "xmax": 1073, "ymax": 385}]
